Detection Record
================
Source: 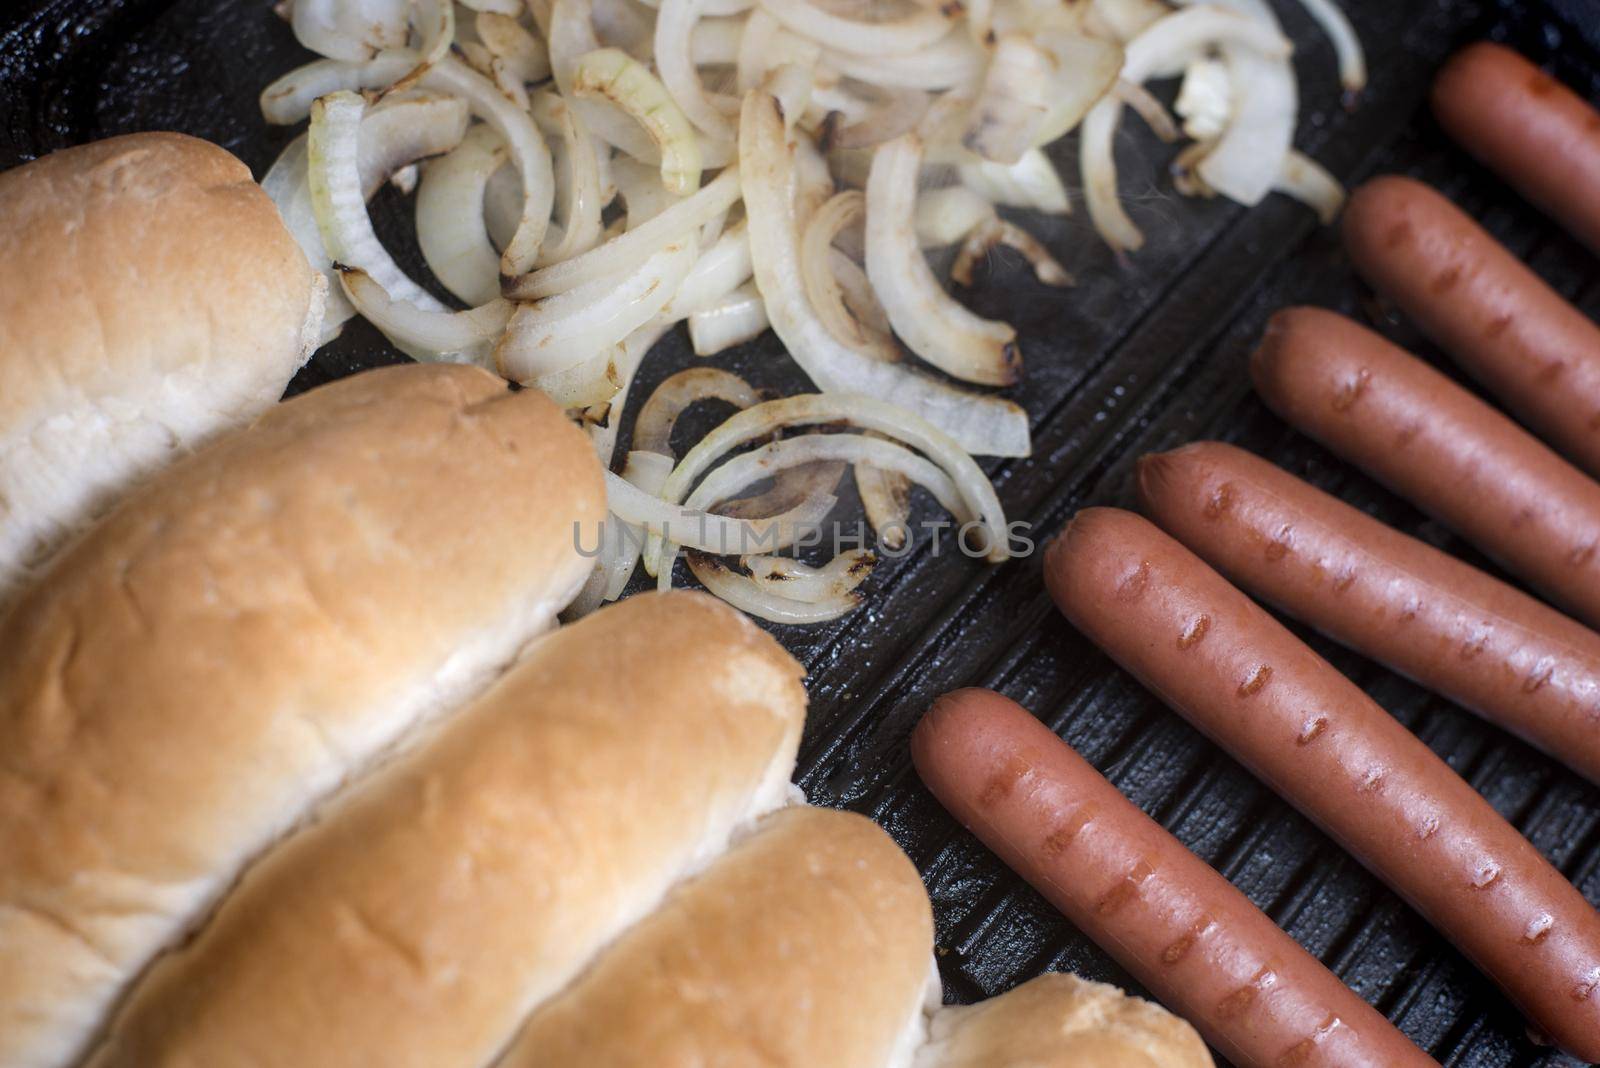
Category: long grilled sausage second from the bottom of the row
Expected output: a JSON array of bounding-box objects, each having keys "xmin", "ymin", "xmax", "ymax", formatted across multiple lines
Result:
[{"xmin": 1045, "ymin": 508, "xmax": 1600, "ymax": 1060}]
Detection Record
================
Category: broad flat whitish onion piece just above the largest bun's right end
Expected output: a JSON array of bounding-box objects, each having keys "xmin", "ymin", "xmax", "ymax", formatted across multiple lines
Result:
[{"xmin": 494, "ymin": 233, "xmax": 699, "ymax": 381}]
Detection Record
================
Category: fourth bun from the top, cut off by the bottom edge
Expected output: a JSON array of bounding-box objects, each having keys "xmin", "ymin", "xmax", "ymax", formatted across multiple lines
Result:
[{"xmin": 496, "ymin": 806, "xmax": 938, "ymax": 1068}]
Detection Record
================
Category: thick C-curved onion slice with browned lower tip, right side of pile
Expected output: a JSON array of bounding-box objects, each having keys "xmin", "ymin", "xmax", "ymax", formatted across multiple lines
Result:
[{"xmin": 867, "ymin": 134, "xmax": 1022, "ymax": 385}]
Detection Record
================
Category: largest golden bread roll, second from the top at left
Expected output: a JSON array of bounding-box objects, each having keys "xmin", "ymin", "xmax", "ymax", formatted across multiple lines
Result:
[{"xmin": 0, "ymin": 365, "xmax": 605, "ymax": 1068}]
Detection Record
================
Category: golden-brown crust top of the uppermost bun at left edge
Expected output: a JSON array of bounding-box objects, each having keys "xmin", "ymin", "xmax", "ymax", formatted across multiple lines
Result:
[{"xmin": 0, "ymin": 133, "xmax": 315, "ymax": 438}]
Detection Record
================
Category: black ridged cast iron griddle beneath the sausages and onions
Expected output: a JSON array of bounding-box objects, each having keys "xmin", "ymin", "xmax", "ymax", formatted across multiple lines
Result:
[{"xmin": 0, "ymin": 0, "xmax": 1600, "ymax": 1066}]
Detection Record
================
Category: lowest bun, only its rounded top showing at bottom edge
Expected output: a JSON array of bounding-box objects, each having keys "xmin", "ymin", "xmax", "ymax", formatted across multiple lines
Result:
[{"xmin": 917, "ymin": 972, "xmax": 1213, "ymax": 1068}]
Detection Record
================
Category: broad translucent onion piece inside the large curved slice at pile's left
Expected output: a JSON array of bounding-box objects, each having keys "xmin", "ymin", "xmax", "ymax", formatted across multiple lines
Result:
[{"xmin": 416, "ymin": 126, "xmax": 506, "ymax": 305}]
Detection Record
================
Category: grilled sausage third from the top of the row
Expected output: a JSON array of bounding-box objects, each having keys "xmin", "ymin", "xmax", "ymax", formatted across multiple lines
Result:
[{"xmin": 1250, "ymin": 309, "xmax": 1600, "ymax": 627}]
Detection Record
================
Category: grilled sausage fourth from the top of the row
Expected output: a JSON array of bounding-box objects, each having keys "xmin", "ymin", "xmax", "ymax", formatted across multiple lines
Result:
[{"xmin": 1139, "ymin": 441, "xmax": 1600, "ymax": 782}]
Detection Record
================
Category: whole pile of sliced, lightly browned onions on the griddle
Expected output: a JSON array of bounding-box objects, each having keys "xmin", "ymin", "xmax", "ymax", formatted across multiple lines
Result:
[{"xmin": 261, "ymin": 0, "xmax": 1365, "ymax": 624}]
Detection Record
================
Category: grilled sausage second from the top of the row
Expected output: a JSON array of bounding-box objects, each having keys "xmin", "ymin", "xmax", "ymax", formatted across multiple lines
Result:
[{"xmin": 1344, "ymin": 177, "xmax": 1600, "ymax": 475}]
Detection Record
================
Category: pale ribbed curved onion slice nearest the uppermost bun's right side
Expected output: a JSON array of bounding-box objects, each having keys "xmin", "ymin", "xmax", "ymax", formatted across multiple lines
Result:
[{"xmin": 306, "ymin": 91, "xmax": 445, "ymax": 312}]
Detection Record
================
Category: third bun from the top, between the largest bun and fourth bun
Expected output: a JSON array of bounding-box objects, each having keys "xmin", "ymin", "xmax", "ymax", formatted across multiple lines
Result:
[{"xmin": 90, "ymin": 592, "xmax": 805, "ymax": 1068}]
